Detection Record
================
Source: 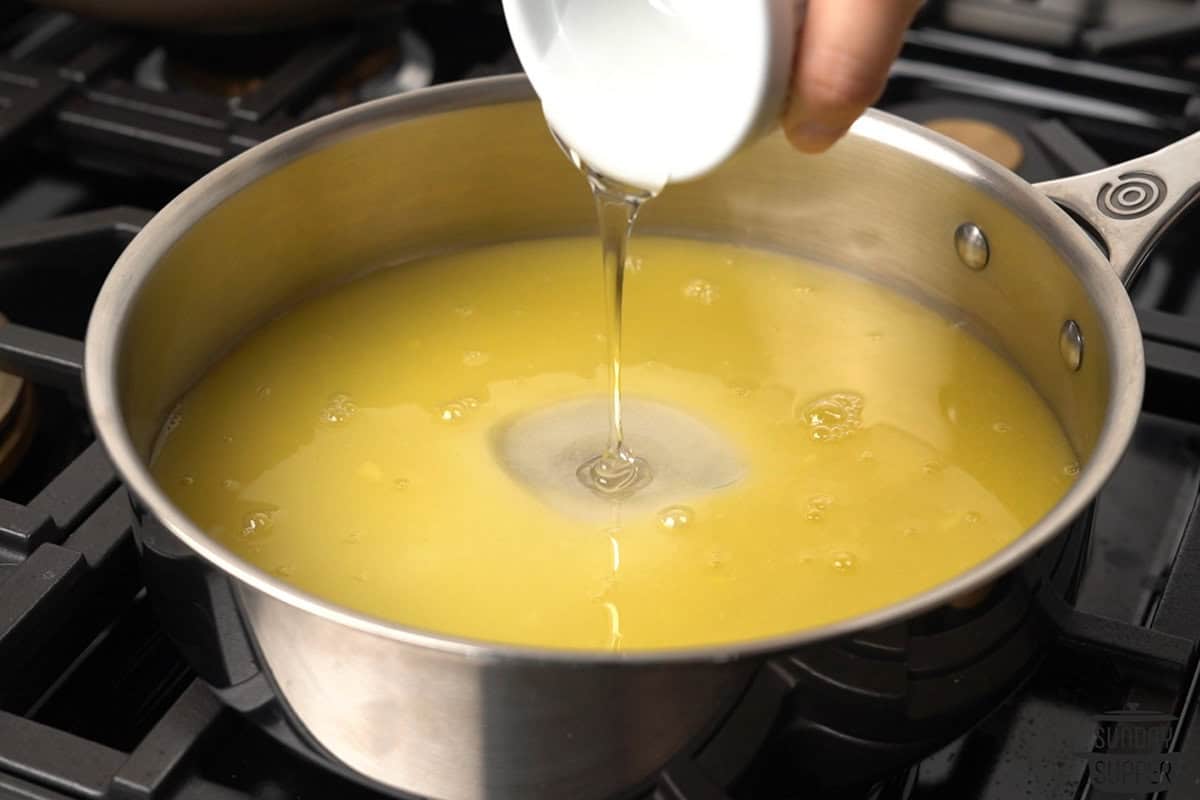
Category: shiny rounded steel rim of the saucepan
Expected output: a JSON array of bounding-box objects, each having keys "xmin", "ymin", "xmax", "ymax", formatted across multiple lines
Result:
[{"xmin": 84, "ymin": 74, "xmax": 1145, "ymax": 666}]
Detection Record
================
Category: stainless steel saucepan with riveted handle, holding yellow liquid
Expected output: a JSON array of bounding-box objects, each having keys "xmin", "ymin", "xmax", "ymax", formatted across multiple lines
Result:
[{"xmin": 85, "ymin": 77, "xmax": 1200, "ymax": 799}]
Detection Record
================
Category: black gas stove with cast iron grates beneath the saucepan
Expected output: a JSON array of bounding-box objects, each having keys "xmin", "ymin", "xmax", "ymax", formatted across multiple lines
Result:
[{"xmin": 0, "ymin": 0, "xmax": 1200, "ymax": 800}]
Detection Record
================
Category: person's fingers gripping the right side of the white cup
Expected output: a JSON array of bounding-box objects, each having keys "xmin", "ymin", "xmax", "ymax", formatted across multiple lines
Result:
[{"xmin": 784, "ymin": 0, "xmax": 920, "ymax": 152}]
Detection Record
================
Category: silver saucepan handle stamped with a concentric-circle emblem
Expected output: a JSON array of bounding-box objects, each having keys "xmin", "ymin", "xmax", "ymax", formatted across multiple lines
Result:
[{"xmin": 1037, "ymin": 133, "xmax": 1200, "ymax": 284}]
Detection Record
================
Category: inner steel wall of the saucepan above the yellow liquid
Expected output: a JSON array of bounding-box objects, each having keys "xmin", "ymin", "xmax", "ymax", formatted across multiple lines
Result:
[{"xmin": 116, "ymin": 94, "xmax": 1111, "ymax": 474}]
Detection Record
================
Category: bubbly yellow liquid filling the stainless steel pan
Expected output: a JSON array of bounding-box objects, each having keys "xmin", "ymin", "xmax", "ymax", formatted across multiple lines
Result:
[{"xmin": 154, "ymin": 239, "xmax": 1078, "ymax": 650}]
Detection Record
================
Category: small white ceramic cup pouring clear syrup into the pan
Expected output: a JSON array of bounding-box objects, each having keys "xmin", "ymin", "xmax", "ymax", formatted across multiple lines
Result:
[{"xmin": 504, "ymin": 0, "xmax": 804, "ymax": 191}]
